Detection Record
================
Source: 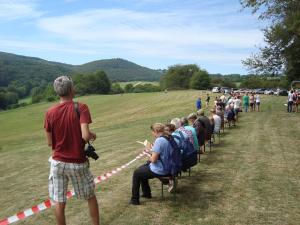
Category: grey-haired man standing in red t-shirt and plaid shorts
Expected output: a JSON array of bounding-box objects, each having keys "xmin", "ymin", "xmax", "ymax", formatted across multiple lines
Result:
[{"xmin": 44, "ymin": 76, "xmax": 100, "ymax": 225}]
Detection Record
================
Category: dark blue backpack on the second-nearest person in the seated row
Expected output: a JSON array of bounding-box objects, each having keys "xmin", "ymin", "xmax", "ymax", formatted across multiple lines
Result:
[{"xmin": 174, "ymin": 131, "xmax": 198, "ymax": 171}]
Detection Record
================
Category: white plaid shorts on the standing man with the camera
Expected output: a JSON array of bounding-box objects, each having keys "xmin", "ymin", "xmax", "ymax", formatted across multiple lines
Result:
[{"xmin": 49, "ymin": 159, "xmax": 95, "ymax": 202}]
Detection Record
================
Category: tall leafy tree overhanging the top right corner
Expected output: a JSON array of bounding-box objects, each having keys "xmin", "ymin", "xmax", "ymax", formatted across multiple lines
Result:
[{"xmin": 240, "ymin": 0, "xmax": 300, "ymax": 81}]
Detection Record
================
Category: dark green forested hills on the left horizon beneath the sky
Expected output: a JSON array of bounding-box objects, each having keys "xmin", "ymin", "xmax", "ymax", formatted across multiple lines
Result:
[{"xmin": 0, "ymin": 52, "xmax": 162, "ymax": 87}]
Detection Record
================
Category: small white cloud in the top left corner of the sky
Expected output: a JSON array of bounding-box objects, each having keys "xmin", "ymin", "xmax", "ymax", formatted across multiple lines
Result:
[{"xmin": 0, "ymin": 0, "xmax": 42, "ymax": 21}]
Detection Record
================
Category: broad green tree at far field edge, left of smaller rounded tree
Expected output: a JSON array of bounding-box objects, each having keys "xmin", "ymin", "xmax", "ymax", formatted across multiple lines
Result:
[{"xmin": 160, "ymin": 64, "xmax": 199, "ymax": 89}]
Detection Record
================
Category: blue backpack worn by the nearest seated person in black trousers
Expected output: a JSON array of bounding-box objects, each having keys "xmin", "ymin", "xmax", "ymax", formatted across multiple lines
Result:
[{"xmin": 160, "ymin": 136, "xmax": 182, "ymax": 176}]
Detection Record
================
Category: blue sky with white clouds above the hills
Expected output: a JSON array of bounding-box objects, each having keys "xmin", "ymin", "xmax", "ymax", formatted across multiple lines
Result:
[{"xmin": 0, "ymin": 0, "xmax": 263, "ymax": 74}]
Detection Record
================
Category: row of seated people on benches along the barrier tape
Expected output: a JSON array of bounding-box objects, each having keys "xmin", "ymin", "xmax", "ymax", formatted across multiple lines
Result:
[{"xmin": 129, "ymin": 108, "xmax": 224, "ymax": 205}]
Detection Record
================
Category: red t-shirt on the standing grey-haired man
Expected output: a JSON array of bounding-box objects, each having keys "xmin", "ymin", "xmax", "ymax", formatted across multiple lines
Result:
[{"xmin": 44, "ymin": 101, "xmax": 92, "ymax": 163}]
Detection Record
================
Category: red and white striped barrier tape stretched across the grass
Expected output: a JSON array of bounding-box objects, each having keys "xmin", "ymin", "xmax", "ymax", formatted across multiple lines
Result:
[{"xmin": 0, "ymin": 151, "xmax": 148, "ymax": 225}]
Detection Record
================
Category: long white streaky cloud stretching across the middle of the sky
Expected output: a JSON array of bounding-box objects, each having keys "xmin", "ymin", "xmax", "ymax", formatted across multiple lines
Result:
[{"xmin": 38, "ymin": 9, "xmax": 262, "ymax": 48}]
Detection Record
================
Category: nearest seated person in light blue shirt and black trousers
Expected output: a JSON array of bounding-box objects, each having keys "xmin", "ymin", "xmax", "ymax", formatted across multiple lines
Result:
[{"xmin": 129, "ymin": 123, "xmax": 172, "ymax": 205}]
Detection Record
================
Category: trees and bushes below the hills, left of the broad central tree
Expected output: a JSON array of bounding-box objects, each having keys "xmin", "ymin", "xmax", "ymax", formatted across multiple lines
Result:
[{"xmin": 0, "ymin": 71, "xmax": 161, "ymax": 110}]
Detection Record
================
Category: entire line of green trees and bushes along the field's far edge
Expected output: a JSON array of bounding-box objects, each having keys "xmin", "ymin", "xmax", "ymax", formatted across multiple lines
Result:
[{"xmin": 0, "ymin": 64, "xmax": 289, "ymax": 110}]
